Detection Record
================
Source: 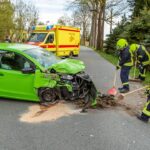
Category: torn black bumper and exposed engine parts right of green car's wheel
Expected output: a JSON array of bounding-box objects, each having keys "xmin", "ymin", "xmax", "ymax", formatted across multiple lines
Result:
[{"xmin": 61, "ymin": 72, "xmax": 97, "ymax": 101}]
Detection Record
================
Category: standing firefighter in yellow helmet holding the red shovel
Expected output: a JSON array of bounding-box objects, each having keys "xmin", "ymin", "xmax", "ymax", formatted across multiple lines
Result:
[{"xmin": 116, "ymin": 39, "xmax": 133, "ymax": 93}]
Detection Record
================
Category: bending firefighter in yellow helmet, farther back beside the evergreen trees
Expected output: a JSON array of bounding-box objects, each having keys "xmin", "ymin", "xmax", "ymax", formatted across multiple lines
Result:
[{"xmin": 130, "ymin": 44, "xmax": 150, "ymax": 81}]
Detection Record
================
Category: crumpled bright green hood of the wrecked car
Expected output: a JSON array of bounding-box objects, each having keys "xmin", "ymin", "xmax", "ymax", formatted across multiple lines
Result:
[{"xmin": 49, "ymin": 58, "xmax": 85, "ymax": 74}]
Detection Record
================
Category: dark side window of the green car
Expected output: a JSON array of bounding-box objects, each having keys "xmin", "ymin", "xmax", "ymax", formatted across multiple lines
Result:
[{"xmin": 0, "ymin": 52, "xmax": 35, "ymax": 71}]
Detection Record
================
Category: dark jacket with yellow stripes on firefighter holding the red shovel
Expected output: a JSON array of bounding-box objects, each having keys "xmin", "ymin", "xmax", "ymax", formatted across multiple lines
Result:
[{"xmin": 119, "ymin": 47, "xmax": 133, "ymax": 67}]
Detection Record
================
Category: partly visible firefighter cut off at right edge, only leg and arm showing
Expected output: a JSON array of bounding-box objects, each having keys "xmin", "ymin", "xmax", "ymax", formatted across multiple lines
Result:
[{"xmin": 137, "ymin": 87, "xmax": 150, "ymax": 122}]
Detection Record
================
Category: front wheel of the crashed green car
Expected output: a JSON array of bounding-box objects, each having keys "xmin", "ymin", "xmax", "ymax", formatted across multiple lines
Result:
[{"xmin": 39, "ymin": 88, "xmax": 57, "ymax": 104}]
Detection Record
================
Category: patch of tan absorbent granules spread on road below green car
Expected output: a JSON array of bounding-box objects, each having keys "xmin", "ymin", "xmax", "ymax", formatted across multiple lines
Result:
[{"xmin": 20, "ymin": 102, "xmax": 81, "ymax": 123}]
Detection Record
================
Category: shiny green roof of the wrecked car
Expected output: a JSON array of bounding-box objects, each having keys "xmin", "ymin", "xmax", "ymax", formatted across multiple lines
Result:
[{"xmin": 0, "ymin": 43, "xmax": 37, "ymax": 52}]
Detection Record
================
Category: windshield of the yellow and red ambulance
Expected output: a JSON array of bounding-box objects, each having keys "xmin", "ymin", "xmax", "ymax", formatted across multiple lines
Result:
[{"xmin": 28, "ymin": 33, "xmax": 47, "ymax": 42}]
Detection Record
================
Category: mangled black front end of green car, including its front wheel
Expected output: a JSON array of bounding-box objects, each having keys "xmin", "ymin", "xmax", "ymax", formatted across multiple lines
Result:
[{"xmin": 39, "ymin": 72, "xmax": 97, "ymax": 107}]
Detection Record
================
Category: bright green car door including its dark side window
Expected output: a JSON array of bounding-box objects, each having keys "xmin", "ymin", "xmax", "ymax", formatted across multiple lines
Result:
[{"xmin": 0, "ymin": 52, "xmax": 37, "ymax": 100}]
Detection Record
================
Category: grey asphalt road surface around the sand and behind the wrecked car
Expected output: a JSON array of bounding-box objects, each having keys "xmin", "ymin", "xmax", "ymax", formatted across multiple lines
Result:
[{"xmin": 0, "ymin": 47, "xmax": 150, "ymax": 150}]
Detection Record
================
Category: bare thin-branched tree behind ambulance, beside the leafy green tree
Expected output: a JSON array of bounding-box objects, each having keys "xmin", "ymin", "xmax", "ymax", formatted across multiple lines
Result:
[{"xmin": 14, "ymin": 0, "xmax": 38, "ymax": 41}]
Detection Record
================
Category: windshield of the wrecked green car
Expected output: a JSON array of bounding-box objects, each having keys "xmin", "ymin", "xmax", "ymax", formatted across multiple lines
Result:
[{"xmin": 24, "ymin": 48, "xmax": 61, "ymax": 68}]
